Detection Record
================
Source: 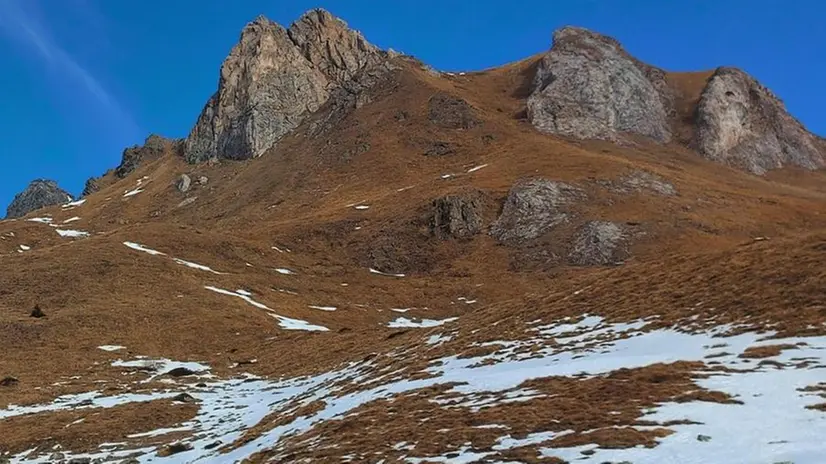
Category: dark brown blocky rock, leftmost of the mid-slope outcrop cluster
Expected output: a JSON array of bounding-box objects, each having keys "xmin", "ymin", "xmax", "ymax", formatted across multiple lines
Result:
[{"xmin": 430, "ymin": 192, "xmax": 483, "ymax": 239}]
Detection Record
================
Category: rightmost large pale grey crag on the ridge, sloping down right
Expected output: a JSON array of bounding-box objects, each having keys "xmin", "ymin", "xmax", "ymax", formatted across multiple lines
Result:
[{"xmin": 695, "ymin": 68, "xmax": 826, "ymax": 174}]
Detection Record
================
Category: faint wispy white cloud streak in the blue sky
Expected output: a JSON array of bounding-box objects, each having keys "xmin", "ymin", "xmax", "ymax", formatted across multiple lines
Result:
[{"xmin": 0, "ymin": 0, "xmax": 138, "ymax": 137}]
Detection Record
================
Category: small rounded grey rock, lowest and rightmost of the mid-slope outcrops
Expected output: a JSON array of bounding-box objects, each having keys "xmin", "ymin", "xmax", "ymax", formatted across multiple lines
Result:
[{"xmin": 568, "ymin": 221, "xmax": 628, "ymax": 266}]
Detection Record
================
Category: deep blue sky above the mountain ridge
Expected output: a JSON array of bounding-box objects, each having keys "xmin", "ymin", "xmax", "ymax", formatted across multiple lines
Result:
[{"xmin": 0, "ymin": 0, "xmax": 826, "ymax": 205}]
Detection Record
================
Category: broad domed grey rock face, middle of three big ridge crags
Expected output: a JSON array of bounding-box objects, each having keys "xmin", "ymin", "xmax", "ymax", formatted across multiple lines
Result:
[{"xmin": 527, "ymin": 27, "xmax": 675, "ymax": 142}]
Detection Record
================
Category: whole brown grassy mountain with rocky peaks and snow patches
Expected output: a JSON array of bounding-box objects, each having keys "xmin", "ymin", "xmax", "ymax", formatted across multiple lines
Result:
[{"xmin": 0, "ymin": 10, "xmax": 826, "ymax": 463}]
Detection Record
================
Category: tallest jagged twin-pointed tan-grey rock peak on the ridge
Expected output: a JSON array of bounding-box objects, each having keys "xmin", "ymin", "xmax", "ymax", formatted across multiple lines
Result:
[{"xmin": 184, "ymin": 10, "xmax": 385, "ymax": 163}]
